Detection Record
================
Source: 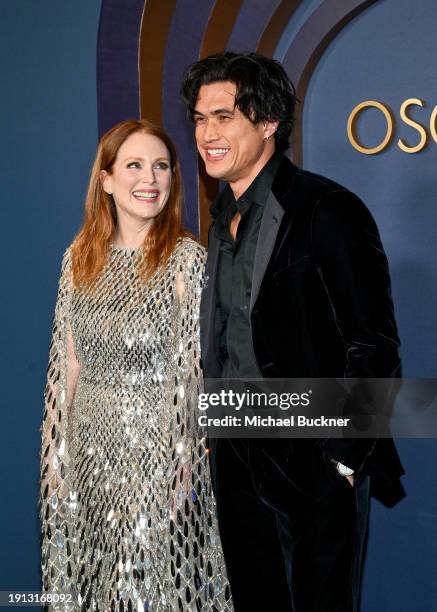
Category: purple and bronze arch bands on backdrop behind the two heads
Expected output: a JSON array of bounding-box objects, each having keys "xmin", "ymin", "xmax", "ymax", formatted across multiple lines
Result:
[{"xmin": 97, "ymin": 0, "xmax": 378, "ymax": 242}]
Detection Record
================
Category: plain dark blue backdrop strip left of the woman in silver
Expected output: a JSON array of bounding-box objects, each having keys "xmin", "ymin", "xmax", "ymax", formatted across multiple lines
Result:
[{"xmin": 0, "ymin": 0, "xmax": 100, "ymax": 604}]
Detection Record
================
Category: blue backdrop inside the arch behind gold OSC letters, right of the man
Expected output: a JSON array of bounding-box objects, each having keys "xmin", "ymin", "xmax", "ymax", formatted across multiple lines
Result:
[{"xmin": 303, "ymin": 0, "xmax": 437, "ymax": 612}]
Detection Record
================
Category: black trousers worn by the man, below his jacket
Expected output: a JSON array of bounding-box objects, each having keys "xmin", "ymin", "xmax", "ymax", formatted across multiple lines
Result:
[{"xmin": 210, "ymin": 439, "xmax": 369, "ymax": 612}]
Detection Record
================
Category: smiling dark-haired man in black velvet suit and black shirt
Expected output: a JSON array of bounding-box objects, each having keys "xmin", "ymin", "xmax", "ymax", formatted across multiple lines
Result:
[{"xmin": 182, "ymin": 53, "xmax": 402, "ymax": 612}]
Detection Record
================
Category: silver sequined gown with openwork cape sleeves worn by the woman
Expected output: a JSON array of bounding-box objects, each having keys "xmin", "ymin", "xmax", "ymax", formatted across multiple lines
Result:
[{"xmin": 41, "ymin": 239, "xmax": 232, "ymax": 612}]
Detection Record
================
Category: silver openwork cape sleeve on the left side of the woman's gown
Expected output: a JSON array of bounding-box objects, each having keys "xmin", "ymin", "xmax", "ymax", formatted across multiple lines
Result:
[{"xmin": 40, "ymin": 251, "xmax": 79, "ymax": 610}]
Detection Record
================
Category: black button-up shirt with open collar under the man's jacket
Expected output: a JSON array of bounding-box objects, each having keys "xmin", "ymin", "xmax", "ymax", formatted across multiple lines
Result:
[{"xmin": 214, "ymin": 153, "xmax": 282, "ymax": 378}]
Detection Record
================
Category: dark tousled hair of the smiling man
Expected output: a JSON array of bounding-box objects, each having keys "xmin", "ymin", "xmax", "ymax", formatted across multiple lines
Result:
[{"xmin": 181, "ymin": 52, "xmax": 296, "ymax": 151}]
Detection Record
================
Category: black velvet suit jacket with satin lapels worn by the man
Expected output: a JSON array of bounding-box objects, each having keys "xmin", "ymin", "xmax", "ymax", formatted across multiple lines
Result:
[{"xmin": 200, "ymin": 157, "xmax": 403, "ymax": 481}]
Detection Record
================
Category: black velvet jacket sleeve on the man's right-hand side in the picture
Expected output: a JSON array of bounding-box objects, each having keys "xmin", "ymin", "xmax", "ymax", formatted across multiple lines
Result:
[{"xmin": 312, "ymin": 191, "xmax": 400, "ymax": 470}]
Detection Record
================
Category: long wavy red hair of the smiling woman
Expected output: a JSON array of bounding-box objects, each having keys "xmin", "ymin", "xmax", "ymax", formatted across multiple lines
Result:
[{"xmin": 71, "ymin": 119, "xmax": 193, "ymax": 289}]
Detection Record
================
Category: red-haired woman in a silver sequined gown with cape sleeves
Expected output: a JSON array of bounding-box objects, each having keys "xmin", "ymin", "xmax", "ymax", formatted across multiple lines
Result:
[{"xmin": 41, "ymin": 120, "xmax": 232, "ymax": 611}]
